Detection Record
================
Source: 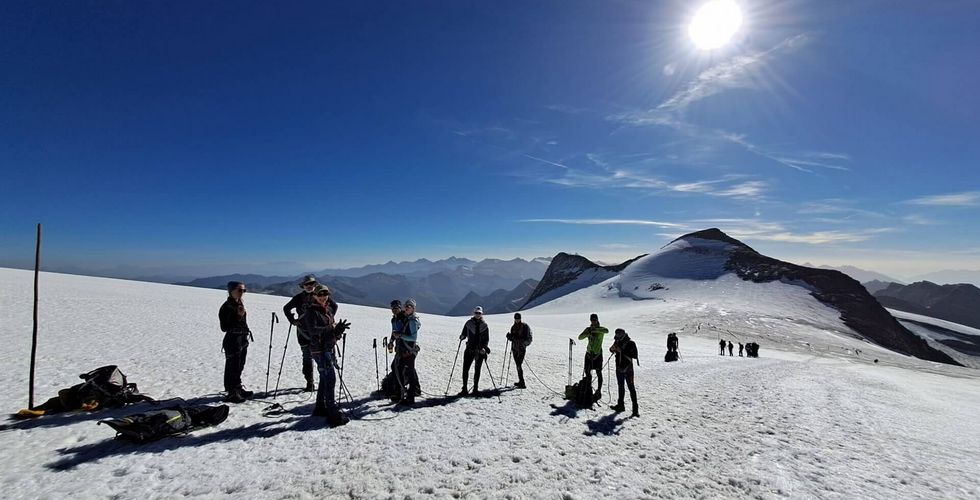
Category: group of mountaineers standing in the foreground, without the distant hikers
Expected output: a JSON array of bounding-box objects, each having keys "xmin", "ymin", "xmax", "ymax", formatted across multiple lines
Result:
[{"xmin": 218, "ymin": 275, "xmax": 652, "ymax": 427}]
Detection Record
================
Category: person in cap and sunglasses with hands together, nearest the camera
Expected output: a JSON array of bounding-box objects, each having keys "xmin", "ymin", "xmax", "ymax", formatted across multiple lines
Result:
[{"xmin": 301, "ymin": 284, "xmax": 350, "ymax": 427}]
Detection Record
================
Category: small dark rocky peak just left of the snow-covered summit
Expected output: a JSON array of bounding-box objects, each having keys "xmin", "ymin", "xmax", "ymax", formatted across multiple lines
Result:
[{"xmin": 521, "ymin": 252, "xmax": 642, "ymax": 309}]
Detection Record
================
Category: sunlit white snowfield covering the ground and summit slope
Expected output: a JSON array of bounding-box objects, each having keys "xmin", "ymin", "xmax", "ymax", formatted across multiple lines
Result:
[{"xmin": 0, "ymin": 269, "xmax": 980, "ymax": 499}]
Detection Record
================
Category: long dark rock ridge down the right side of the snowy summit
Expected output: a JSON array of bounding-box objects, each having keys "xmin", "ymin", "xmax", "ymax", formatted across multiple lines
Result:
[{"xmin": 675, "ymin": 228, "xmax": 959, "ymax": 365}]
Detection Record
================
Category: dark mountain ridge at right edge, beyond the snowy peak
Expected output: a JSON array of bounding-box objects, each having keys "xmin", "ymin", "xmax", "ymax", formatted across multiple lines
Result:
[{"xmin": 875, "ymin": 281, "xmax": 980, "ymax": 328}]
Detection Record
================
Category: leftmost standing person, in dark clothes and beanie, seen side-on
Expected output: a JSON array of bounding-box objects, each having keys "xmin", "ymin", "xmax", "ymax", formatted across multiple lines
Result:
[{"xmin": 218, "ymin": 281, "xmax": 252, "ymax": 403}]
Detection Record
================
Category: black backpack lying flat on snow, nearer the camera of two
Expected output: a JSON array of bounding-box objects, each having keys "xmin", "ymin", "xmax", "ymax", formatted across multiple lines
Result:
[{"xmin": 99, "ymin": 405, "xmax": 228, "ymax": 443}]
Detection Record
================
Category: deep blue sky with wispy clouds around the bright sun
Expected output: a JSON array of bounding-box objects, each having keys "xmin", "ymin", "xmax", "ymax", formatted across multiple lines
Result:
[{"xmin": 0, "ymin": 0, "xmax": 980, "ymax": 278}]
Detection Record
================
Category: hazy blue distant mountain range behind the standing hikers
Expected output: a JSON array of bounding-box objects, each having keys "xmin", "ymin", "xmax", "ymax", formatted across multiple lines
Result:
[{"xmin": 179, "ymin": 257, "xmax": 551, "ymax": 315}]
